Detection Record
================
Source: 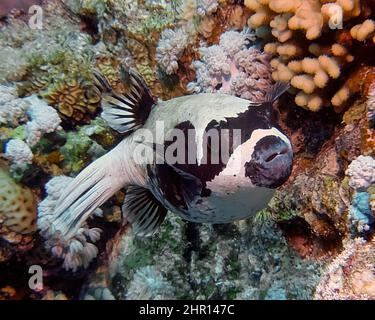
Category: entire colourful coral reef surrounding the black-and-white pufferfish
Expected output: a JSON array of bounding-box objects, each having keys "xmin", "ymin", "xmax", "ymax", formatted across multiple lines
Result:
[{"xmin": 0, "ymin": 0, "xmax": 375, "ymax": 300}]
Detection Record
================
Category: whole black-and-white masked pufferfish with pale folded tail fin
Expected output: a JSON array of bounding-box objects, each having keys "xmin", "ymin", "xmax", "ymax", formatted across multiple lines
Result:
[{"xmin": 41, "ymin": 70, "xmax": 293, "ymax": 268}]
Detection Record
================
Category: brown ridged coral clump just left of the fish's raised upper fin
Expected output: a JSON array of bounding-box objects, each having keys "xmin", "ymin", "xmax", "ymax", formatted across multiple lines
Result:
[{"xmin": 42, "ymin": 79, "xmax": 101, "ymax": 124}]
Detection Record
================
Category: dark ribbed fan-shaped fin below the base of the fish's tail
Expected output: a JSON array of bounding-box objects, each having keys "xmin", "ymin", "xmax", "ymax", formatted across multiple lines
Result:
[{"xmin": 122, "ymin": 186, "xmax": 168, "ymax": 237}]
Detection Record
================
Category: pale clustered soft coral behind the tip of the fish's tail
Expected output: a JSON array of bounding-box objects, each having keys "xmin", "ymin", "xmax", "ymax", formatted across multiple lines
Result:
[{"xmin": 38, "ymin": 176, "xmax": 101, "ymax": 271}]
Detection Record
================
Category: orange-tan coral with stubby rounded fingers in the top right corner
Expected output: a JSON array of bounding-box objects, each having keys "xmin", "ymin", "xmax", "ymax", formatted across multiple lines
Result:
[{"xmin": 245, "ymin": 0, "xmax": 375, "ymax": 112}]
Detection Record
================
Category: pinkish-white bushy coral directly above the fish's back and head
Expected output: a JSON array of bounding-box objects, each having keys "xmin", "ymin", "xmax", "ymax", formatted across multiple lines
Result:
[{"xmin": 188, "ymin": 30, "xmax": 271, "ymax": 101}]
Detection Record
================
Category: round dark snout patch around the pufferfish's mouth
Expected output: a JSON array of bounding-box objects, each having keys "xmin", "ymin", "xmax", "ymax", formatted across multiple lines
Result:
[{"xmin": 245, "ymin": 136, "xmax": 293, "ymax": 188}]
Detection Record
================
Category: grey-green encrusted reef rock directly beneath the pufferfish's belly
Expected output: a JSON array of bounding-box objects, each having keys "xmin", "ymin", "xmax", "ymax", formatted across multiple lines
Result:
[{"xmin": 99, "ymin": 214, "xmax": 320, "ymax": 299}]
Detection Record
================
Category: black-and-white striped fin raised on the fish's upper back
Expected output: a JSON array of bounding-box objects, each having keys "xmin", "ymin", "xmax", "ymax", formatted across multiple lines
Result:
[{"xmin": 94, "ymin": 69, "xmax": 155, "ymax": 133}]
